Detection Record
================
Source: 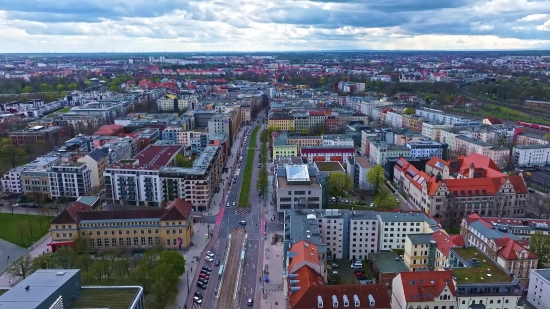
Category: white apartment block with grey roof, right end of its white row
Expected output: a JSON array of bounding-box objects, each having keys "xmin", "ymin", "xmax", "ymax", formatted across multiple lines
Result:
[{"xmin": 378, "ymin": 211, "xmax": 440, "ymax": 250}]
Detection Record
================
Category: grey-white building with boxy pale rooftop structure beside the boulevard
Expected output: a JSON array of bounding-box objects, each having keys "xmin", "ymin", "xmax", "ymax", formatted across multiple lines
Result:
[{"xmin": 274, "ymin": 164, "xmax": 323, "ymax": 212}]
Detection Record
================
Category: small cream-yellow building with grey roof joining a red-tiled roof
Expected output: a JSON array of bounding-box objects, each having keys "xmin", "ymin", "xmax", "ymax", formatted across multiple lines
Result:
[{"xmin": 403, "ymin": 230, "xmax": 464, "ymax": 271}]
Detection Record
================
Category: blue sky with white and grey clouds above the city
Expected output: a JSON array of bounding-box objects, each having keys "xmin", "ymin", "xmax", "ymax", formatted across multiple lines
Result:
[{"xmin": 0, "ymin": 0, "xmax": 550, "ymax": 53}]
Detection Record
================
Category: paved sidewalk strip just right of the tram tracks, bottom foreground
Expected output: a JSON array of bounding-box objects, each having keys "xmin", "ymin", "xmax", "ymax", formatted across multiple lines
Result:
[{"xmin": 260, "ymin": 233, "xmax": 286, "ymax": 309}]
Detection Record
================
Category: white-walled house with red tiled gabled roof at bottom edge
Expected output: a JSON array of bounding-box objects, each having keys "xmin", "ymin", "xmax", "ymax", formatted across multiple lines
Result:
[{"xmin": 391, "ymin": 270, "xmax": 457, "ymax": 309}]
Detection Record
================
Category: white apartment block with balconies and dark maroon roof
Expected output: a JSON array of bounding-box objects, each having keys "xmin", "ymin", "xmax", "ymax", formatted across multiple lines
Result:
[{"xmin": 103, "ymin": 145, "xmax": 187, "ymax": 207}]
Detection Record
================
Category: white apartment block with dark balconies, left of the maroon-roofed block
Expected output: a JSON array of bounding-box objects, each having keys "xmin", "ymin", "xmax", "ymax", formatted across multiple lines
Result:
[{"xmin": 48, "ymin": 162, "xmax": 92, "ymax": 198}]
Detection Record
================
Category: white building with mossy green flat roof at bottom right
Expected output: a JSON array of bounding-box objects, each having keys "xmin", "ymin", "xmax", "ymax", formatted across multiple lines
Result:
[{"xmin": 449, "ymin": 247, "xmax": 522, "ymax": 309}]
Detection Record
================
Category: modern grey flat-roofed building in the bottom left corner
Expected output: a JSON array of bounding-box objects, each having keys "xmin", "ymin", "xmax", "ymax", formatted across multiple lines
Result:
[{"xmin": 0, "ymin": 269, "xmax": 145, "ymax": 309}]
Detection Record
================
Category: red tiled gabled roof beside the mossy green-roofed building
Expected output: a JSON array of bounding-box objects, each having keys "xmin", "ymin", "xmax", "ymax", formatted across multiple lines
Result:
[{"xmin": 398, "ymin": 270, "xmax": 456, "ymax": 303}]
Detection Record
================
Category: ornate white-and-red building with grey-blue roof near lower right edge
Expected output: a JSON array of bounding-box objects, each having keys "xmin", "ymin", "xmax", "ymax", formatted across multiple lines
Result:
[{"xmin": 460, "ymin": 213, "xmax": 538, "ymax": 286}]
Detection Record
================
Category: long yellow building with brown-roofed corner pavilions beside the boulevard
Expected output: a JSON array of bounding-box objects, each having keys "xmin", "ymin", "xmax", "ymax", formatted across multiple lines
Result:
[{"xmin": 48, "ymin": 198, "xmax": 193, "ymax": 252}]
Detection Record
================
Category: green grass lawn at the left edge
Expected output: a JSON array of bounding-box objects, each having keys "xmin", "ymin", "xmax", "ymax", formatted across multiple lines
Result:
[{"xmin": 0, "ymin": 212, "xmax": 54, "ymax": 248}]
